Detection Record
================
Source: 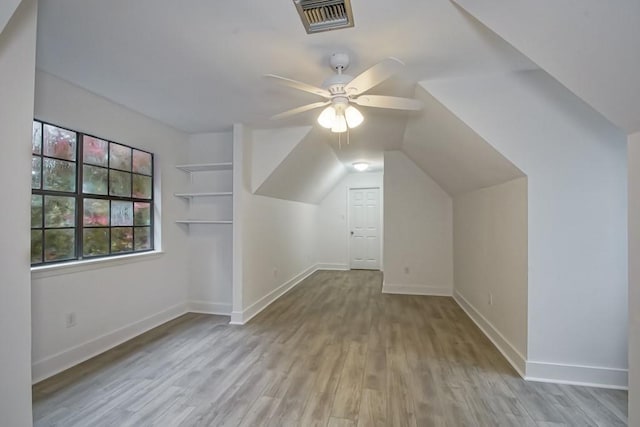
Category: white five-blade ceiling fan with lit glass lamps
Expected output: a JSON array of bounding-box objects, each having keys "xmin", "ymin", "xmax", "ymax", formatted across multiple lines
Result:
[{"xmin": 265, "ymin": 53, "xmax": 422, "ymax": 133}]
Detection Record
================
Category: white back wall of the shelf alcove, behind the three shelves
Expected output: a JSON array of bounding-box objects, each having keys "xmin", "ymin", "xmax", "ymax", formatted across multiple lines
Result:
[{"xmin": 186, "ymin": 132, "xmax": 233, "ymax": 315}]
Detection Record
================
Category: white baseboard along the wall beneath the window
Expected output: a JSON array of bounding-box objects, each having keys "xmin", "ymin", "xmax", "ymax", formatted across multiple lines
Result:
[{"xmin": 31, "ymin": 304, "xmax": 187, "ymax": 384}]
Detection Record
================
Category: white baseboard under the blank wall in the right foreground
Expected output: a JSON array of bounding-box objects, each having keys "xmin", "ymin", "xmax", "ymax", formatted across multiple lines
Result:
[{"xmin": 525, "ymin": 361, "xmax": 629, "ymax": 390}]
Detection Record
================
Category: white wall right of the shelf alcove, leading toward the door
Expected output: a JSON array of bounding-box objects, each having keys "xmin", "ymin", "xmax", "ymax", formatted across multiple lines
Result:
[{"xmin": 232, "ymin": 125, "xmax": 318, "ymax": 323}]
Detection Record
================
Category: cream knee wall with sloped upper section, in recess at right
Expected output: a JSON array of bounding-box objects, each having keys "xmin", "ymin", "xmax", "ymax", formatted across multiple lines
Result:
[{"xmin": 402, "ymin": 79, "xmax": 527, "ymax": 375}]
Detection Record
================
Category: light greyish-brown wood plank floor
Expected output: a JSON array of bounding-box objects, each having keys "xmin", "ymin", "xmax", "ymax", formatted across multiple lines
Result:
[{"xmin": 33, "ymin": 271, "xmax": 627, "ymax": 427}]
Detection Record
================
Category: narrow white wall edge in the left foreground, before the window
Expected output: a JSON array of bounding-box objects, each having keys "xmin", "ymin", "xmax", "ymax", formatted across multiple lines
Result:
[{"xmin": 0, "ymin": 0, "xmax": 37, "ymax": 427}]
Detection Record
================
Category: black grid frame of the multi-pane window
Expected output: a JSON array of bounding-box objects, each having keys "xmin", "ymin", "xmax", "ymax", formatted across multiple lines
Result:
[{"xmin": 30, "ymin": 118, "xmax": 156, "ymax": 268}]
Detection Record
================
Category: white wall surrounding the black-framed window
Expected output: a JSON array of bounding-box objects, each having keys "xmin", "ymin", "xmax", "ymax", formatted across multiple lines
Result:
[{"xmin": 32, "ymin": 72, "xmax": 188, "ymax": 381}]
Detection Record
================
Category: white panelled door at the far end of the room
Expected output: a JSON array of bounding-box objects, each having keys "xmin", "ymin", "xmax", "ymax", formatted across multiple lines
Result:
[{"xmin": 349, "ymin": 188, "xmax": 380, "ymax": 270}]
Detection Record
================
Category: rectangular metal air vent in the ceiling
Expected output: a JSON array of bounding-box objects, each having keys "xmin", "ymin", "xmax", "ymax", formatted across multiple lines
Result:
[{"xmin": 293, "ymin": 0, "xmax": 353, "ymax": 34}]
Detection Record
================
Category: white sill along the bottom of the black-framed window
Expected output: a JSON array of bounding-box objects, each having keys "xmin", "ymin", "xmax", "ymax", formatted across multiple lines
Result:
[{"xmin": 31, "ymin": 251, "xmax": 164, "ymax": 280}]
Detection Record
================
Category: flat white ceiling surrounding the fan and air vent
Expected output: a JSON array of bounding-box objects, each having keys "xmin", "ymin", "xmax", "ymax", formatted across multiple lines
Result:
[{"xmin": 37, "ymin": 0, "xmax": 535, "ymax": 169}]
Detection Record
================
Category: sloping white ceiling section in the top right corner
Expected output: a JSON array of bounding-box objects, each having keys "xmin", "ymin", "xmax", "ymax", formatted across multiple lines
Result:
[{"xmin": 454, "ymin": 0, "xmax": 640, "ymax": 133}]
